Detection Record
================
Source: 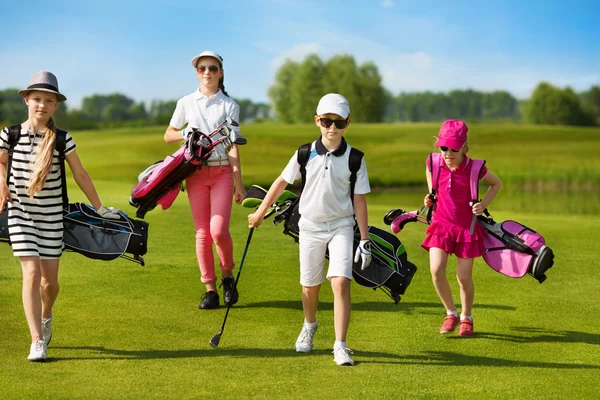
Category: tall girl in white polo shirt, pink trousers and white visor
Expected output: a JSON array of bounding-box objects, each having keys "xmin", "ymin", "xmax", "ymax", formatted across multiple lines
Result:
[{"xmin": 165, "ymin": 51, "xmax": 246, "ymax": 309}]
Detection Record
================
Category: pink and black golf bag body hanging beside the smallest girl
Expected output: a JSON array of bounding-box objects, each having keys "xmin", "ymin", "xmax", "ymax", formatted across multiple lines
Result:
[{"xmin": 480, "ymin": 218, "xmax": 554, "ymax": 283}]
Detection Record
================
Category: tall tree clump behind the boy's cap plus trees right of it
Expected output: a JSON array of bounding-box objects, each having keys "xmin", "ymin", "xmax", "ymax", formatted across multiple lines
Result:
[{"xmin": 269, "ymin": 54, "xmax": 600, "ymax": 126}]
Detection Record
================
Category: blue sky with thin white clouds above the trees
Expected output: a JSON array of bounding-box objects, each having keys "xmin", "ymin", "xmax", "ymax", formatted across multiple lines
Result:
[{"xmin": 0, "ymin": 0, "xmax": 600, "ymax": 108}]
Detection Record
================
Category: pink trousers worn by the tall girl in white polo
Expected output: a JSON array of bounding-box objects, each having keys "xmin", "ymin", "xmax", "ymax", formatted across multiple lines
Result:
[{"xmin": 186, "ymin": 165, "xmax": 235, "ymax": 283}]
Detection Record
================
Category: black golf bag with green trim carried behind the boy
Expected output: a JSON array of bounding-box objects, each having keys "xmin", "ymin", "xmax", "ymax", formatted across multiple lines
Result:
[{"xmin": 273, "ymin": 198, "xmax": 417, "ymax": 304}]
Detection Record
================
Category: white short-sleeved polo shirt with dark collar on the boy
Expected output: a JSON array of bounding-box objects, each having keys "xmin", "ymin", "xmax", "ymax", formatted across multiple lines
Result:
[{"xmin": 281, "ymin": 138, "xmax": 371, "ymax": 222}]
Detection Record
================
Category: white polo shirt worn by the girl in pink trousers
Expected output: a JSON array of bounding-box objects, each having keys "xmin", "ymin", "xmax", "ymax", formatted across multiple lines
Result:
[{"xmin": 169, "ymin": 89, "xmax": 240, "ymax": 162}]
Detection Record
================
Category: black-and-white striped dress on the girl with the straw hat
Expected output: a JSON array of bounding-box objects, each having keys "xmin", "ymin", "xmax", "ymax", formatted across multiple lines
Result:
[{"xmin": 0, "ymin": 128, "xmax": 75, "ymax": 259}]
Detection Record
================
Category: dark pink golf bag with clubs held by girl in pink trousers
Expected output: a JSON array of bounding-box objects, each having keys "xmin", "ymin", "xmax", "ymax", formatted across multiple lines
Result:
[{"xmin": 129, "ymin": 119, "xmax": 246, "ymax": 218}]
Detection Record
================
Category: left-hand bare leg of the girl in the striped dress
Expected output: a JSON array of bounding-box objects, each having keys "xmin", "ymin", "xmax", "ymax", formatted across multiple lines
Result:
[{"xmin": 19, "ymin": 257, "xmax": 42, "ymax": 342}]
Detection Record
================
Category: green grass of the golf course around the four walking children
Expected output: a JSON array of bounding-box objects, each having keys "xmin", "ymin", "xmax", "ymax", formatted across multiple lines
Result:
[{"xmin": 0, "ymin": 124, "xmax": 600, "ymax": 399}]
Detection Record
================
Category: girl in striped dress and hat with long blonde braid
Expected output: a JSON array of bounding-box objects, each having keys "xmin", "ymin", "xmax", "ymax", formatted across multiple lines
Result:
[{"xmin": 0, "ymin": 71, "xmax": 119, "ymax": 361}]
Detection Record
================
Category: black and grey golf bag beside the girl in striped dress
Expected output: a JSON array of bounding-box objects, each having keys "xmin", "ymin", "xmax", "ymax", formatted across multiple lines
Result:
[{"xmin": 63, "ymin": 203, "xmax": 148, "ymax": 265}]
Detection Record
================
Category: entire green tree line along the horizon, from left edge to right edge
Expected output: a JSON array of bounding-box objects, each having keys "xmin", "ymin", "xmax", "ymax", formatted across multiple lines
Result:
[{"xmin": 0, "ymin": 54, "xmax": 600, "ymax": 129}]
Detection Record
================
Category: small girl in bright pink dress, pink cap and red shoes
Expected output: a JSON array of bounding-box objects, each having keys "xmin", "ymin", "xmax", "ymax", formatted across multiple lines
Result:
[{"xmin": 421, "ymin": 120, "xmax": 502, "ymax": 336}]
